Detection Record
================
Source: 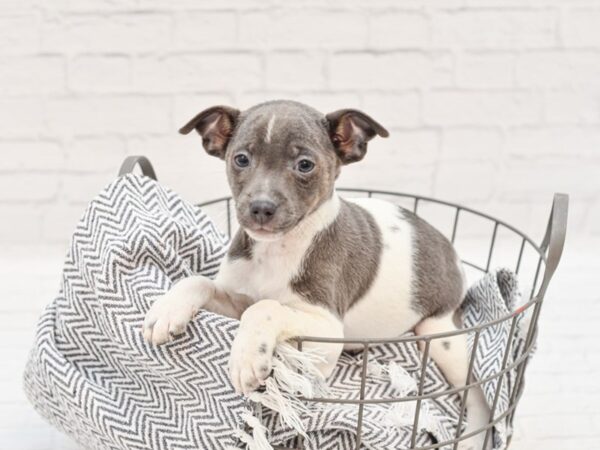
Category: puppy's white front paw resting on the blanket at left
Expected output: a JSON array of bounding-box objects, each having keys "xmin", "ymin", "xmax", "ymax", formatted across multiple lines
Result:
[{"xmin": 144, "ymin": 291, "xmax": 198, "ymax": 345}]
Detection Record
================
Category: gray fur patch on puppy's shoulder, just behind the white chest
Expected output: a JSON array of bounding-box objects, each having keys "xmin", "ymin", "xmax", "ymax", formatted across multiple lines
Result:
[{"xmin": 291, "ymin": 199, "xmax": 383, "ymax": 317}]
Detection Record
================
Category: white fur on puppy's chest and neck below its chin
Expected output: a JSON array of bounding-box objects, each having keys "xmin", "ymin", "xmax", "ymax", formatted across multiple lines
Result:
[{"xmin": 216, "ymin": 193, "xmax": 340, "ymax": 304}]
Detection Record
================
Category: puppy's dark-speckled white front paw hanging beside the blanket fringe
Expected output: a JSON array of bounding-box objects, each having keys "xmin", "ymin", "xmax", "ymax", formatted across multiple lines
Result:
[{"xmin": 229, "ymin": 328, "xmax": 276, "ymax": 395}]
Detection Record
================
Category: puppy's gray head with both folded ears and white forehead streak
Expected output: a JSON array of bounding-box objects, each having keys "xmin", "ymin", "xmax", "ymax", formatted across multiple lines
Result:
[{"xmin": 180, "ymin": 101, "xmax": 388, "ymax": 240}]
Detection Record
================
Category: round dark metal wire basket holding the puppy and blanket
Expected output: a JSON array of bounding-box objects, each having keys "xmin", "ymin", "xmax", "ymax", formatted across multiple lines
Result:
[{"xmin": 119, "ymin": 156, "xmax": 569, "ymax": 450}]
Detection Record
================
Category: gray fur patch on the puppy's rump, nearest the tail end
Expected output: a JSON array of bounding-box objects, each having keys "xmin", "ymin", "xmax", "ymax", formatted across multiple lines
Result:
[{"xmin": 398, "ymin": 207, "xmax": 464, "ymax": 317}]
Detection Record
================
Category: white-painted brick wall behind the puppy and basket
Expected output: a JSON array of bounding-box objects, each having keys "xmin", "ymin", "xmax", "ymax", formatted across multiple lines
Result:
[{"xmin": 0, "ymin": 0, "xmax": 600, "ymax": 244}]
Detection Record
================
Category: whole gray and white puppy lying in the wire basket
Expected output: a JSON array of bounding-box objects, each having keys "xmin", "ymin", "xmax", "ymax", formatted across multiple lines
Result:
[{"xmin": 144, "ymin": 101, "xmax": 488, "ymax": 449}]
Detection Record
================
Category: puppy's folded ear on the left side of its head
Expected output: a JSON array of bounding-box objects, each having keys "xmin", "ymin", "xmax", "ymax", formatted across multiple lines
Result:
[{"xmin": 179, "ymin": 106, "xmax": 240, "ymax": 159}]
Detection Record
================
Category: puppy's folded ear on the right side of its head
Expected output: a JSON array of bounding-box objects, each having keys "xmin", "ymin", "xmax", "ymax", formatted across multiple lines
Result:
[{"xmin": 325, "ymin": 109, "xmax": 389, "ymax": 164}]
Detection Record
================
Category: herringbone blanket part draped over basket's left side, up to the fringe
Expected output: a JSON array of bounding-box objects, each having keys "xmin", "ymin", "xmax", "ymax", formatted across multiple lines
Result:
[{"xmin": 25, "ymin": 175, "xmax": 244, "ymax": 449}]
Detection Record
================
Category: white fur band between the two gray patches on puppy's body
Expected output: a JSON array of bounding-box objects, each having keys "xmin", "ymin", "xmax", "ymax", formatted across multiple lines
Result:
[{"xmin": 344, "ymin": 198, "xmax": 421, "ymax": 347}]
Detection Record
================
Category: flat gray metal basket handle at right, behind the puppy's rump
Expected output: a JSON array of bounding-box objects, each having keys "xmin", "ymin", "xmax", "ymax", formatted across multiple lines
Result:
[{"xmin": 537, "ymin": 194, "xmax": 569, "ymax": 298}]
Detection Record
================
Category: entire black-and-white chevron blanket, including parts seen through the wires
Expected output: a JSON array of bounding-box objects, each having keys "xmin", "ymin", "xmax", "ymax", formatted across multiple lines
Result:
[{"xmin": 24, "ymin": 175, "xmax": 524, "ymax": 450}]
